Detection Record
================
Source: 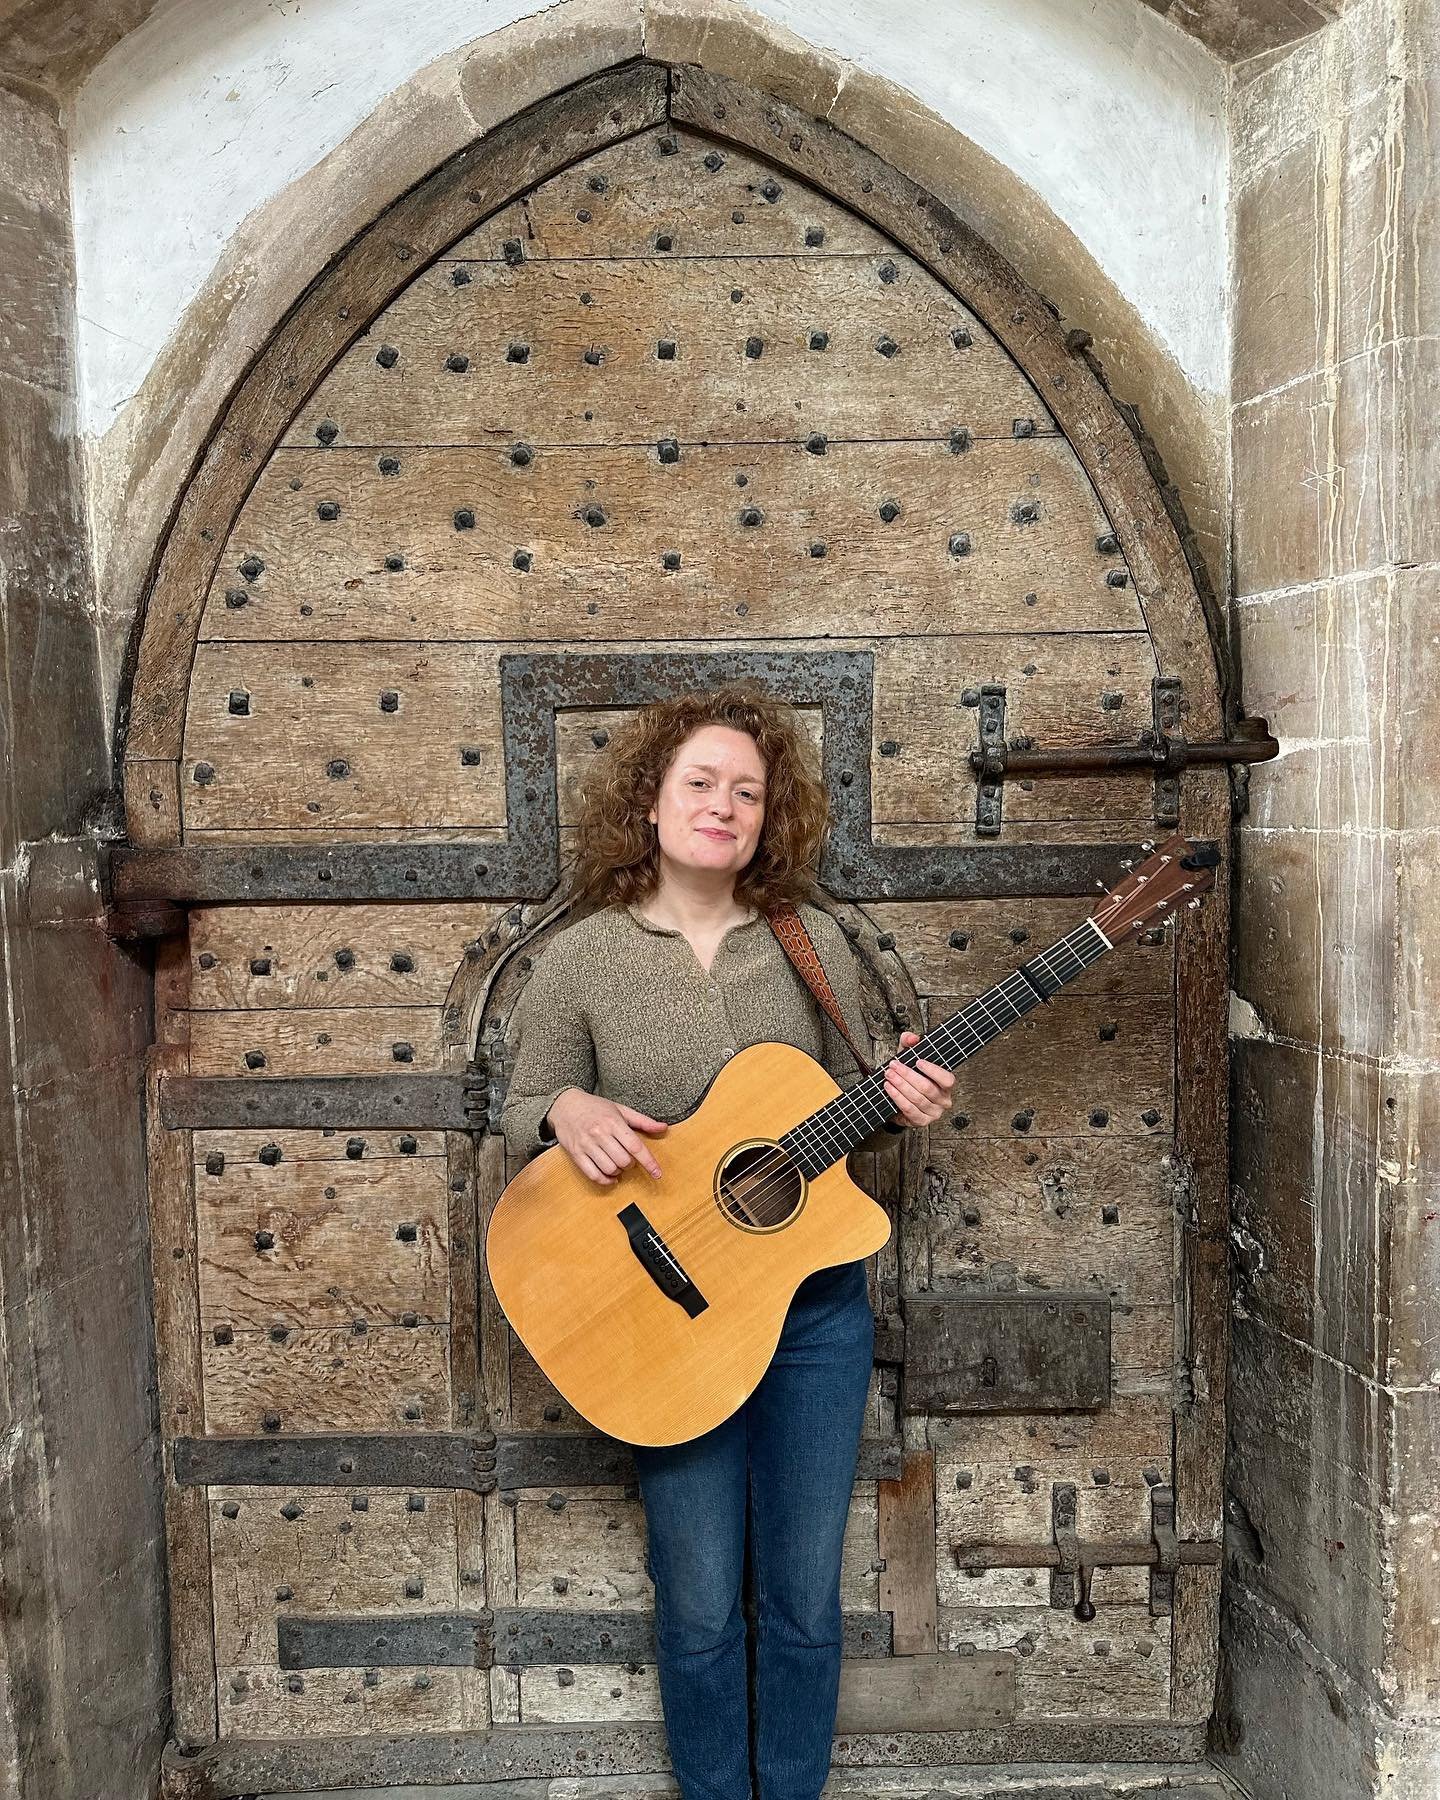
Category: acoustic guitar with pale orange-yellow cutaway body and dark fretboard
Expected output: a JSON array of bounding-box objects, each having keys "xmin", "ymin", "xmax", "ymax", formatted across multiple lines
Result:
[{"xmin": 484, "ymin": 833, "xmax": 1220, "ymax": 1444}]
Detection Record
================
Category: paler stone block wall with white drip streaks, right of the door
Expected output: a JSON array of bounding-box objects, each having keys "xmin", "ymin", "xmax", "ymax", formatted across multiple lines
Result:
[{"xmin": 1226, "ymin": 0, "xmax": 1440, "ymax": 1800}]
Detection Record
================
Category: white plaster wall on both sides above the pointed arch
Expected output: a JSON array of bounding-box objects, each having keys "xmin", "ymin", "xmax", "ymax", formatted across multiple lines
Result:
[{"xmin": 72, "ymin": 0, "xmax": 1229, "ymax": 437}]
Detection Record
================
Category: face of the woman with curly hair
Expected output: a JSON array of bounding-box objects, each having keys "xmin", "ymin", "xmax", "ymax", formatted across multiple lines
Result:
[{"xmin": 646, "ymin": 725, "xmax": 765, "ymax": 878}]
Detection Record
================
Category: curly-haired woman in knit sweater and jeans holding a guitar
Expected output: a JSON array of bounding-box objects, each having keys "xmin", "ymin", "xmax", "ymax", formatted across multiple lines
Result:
[{"xmin": 500, "ymin": 682, "xmax": 954, "ymax": 1800}]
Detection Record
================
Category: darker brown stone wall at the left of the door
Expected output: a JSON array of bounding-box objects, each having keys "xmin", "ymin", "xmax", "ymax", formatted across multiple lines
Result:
[{"xmin": 0, "ymin": 86, "xmax": 167, "ymax": 1800}]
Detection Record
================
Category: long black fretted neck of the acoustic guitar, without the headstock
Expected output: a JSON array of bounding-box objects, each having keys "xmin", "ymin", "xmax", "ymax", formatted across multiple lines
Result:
[{"xmin": 779, "ymin": 918, "xmax": 1114, "ymax": 1177}]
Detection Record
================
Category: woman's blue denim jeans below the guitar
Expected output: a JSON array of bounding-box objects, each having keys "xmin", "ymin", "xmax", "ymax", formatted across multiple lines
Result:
[{"xmin": 634, "ymin": 1260, "xmax": 875, "ymax": 1800}]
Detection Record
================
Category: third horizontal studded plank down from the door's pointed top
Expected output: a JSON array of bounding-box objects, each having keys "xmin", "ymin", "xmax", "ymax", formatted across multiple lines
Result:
[{"xmin": 210, "ymin": 439, "xmax": 1148, "ymax": 644}]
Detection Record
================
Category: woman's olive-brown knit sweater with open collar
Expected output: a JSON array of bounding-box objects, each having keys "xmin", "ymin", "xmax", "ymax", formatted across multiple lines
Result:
[{"xmin": 500, "ymin": 900, "xmax": 898, "ymax": 1157}]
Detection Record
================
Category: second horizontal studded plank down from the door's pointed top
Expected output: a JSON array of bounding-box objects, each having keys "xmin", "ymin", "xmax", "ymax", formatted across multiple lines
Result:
[{"xmin": 284, "ymin": 256, "xmax": 1057, "ymax": 446}]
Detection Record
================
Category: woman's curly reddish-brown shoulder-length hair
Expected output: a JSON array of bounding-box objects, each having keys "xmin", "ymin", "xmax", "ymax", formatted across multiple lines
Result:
[{"xmin": 569, "ymin": 677, "xmax": 830, "ymax": 914}]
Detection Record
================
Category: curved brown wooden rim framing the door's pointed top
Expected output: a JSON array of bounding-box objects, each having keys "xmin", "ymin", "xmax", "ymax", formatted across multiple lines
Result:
[{"xmin": 124, "ymin": 58, "xmax": 1226, "ymax": 848}]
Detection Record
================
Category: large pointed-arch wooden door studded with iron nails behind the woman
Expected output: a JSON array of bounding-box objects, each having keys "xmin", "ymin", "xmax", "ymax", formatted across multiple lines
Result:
[{"xmin": 121, "ymin": 65, "xmax": 1229, "ymax": 1793}]
